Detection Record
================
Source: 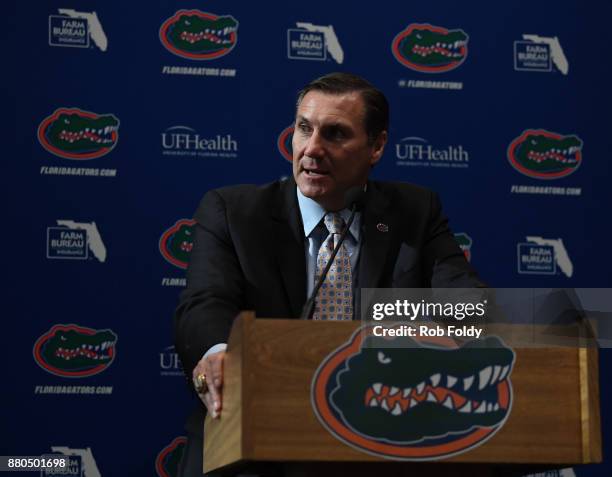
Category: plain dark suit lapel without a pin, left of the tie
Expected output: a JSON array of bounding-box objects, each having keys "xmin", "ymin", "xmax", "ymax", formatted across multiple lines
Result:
[{"xmin": 269, "ymin": 179, "xmax": 306, "ymax": 317}]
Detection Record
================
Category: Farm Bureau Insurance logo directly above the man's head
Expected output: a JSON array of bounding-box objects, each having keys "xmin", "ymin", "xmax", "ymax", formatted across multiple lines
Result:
[{"xmin": 287, "ymin": 22, "xmax": 344, "ymax": 64}]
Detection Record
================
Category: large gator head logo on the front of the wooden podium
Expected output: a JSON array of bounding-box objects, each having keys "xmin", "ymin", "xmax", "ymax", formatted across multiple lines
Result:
[{"xmin": 311, "ymin": 328, "xmax": 515, "ymax": 461}]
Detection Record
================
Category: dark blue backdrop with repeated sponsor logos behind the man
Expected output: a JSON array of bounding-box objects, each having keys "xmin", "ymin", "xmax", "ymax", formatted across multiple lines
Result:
[{"xmin": 5, "ymin": 0, "xmax": 612, "ymax": 476}]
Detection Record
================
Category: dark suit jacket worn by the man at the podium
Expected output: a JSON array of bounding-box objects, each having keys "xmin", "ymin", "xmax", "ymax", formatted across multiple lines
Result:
[{"xmin": 175, "ymin": 179, "xmax": 484, "ymax": 433}]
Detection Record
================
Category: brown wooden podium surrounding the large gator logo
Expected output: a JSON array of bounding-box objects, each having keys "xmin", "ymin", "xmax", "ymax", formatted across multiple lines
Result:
[{"xmin": 204, "ymin": 312, "xmax": 602, "ymax": 477}]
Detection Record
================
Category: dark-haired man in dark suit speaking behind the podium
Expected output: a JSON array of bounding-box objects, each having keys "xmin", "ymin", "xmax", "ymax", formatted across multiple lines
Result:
[{"xmin": 175, "ymin": 73, "xmax": 482, "ymax": 475}]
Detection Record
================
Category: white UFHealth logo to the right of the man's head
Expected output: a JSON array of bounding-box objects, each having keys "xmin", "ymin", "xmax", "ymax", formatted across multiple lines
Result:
[{"xmin": 395, "ymin": 136, "xmax": 470, "ymax": 168}]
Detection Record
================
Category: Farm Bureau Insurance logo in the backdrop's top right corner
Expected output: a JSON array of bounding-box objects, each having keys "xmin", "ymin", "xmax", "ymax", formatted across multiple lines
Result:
[{"xmin": 514, "ymin": 35, "xmax": 569, "ymax": 75}]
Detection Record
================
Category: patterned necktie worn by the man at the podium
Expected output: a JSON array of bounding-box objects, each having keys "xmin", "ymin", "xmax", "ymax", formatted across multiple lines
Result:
[{"xmin": 312, "ymin": 212, "xmax": 353, "ymax": 320}]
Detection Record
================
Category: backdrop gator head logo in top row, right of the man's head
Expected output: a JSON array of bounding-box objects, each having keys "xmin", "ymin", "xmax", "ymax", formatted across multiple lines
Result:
[{"xmin": 391, "ymin": 23, "xmax": 469, "ymax": 73}]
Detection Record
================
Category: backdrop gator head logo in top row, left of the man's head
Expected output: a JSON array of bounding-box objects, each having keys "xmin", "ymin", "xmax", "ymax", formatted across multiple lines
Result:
[{"xmin": 159, "ymin": 10, "xmax": 238, "ymax": 60}]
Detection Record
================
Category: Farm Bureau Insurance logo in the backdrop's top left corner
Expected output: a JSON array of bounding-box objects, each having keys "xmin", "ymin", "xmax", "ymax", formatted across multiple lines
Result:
[{"xmin": 49, "ymin": 8, "xmax": 108, "ymax": 51}]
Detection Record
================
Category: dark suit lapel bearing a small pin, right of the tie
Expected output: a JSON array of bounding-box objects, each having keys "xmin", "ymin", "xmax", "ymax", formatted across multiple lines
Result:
[{"xmin": 359, "ymin": 182, "xmax": 398, "ymax": 288}]
